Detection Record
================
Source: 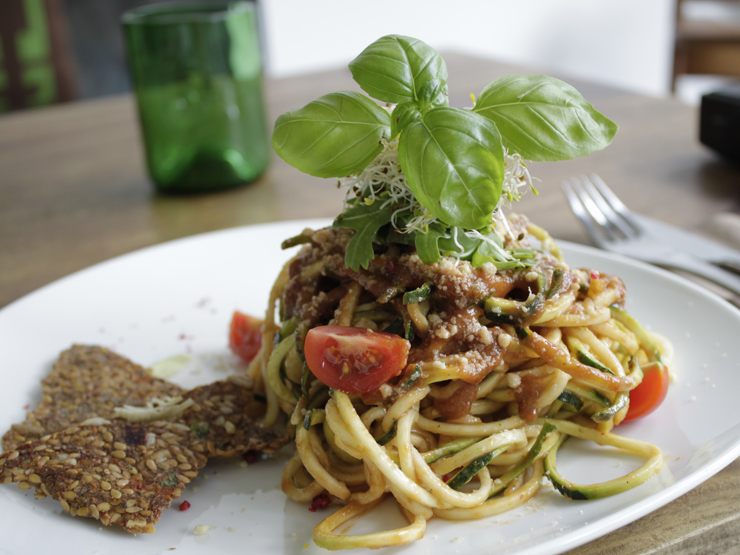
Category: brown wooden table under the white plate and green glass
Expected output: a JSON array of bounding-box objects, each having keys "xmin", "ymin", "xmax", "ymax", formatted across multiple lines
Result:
[{"xmin": 0, "ymin": 54, "xmax": 740, "ymax": 554}]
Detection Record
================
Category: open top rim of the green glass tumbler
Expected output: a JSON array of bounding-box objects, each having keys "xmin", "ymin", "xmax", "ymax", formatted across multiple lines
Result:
[{"xmin": 121, "ymin": 0, "xmax": 255, "ymax": 26}]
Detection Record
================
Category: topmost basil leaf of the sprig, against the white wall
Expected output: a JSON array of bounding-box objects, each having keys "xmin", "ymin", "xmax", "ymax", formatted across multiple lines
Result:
[{"xmin": 349, "ymin": 35, "xmax": 447, "ymax": 103}]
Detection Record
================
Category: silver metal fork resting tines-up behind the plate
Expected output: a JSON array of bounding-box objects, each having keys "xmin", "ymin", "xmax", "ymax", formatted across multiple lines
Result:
[{"xmin": 562, "ymin": 175, "xmax": 740, "ymax": 295}]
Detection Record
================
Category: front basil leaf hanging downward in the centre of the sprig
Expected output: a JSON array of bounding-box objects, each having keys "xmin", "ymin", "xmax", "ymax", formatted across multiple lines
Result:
[{"xmin": 398, "ymin": 107, "xmax": 504, "ymax": 229}]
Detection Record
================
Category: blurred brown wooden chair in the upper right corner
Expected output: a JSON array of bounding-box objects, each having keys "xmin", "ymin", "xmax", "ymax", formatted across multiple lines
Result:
[{"xmin": 671, "ymin": 0, "xmax": 740, "ymax": 93}]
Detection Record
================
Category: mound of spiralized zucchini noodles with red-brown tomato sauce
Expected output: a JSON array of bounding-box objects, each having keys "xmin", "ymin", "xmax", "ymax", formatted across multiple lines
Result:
[{"xmin": 244, "ymin": 216, "xmax": 670, "ymax": 549}]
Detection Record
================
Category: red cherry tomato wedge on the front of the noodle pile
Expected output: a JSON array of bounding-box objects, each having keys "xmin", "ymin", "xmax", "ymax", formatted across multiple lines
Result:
[{"xmin": 304, "ymin": 326, "xmax": 411, "ymax": 393}]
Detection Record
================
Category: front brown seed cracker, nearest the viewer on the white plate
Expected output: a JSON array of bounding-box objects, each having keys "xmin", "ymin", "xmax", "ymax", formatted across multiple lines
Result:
[{"xmin": 0, "ymin": 420, "xmax": 207, "ymax": 534}]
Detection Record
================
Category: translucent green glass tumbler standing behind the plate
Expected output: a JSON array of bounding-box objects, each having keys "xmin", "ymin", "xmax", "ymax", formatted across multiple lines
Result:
[{"xmin": 122, "ymin": 2, "xmax": 270, "ymax": 193}]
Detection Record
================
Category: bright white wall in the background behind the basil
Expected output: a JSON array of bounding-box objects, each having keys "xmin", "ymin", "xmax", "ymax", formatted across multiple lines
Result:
[{"xmin": 262, "ymin": 0, "xmax": 675, "ymax": 95}]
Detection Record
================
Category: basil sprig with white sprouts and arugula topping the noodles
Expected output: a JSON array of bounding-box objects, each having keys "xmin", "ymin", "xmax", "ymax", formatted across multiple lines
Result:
[{"xmin": 272, "ymin": 35, "xmax": 617, "ymax": 270}]
